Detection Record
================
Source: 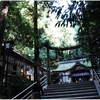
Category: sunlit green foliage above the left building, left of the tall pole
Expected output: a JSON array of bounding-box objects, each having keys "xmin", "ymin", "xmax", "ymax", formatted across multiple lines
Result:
[{"xmin": 4, "ymin": 1, "xmax": 43, "ymax": 59}]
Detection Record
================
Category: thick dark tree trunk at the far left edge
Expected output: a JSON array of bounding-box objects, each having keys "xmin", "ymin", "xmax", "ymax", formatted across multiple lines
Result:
[{"xmin": 0, "ymin": 1, "xmax": 9, "ymax": 85}]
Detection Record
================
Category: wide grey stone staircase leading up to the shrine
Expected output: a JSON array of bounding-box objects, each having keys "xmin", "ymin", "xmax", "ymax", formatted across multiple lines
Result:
[{"xmin": 42, "ymin": 81, "xmax": 99, "ymax": 99}]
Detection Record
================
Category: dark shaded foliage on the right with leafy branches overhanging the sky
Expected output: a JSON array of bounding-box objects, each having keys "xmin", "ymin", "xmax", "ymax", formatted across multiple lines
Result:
[{"xmin": 50, "ymin": 1, "xmax": 100, "ymax": 67}]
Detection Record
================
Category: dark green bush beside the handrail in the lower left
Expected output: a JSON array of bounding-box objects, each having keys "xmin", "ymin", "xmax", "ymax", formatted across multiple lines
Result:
[{"xmin": 0, "ymin": 76, "xmax": 32, "ymax": 99}]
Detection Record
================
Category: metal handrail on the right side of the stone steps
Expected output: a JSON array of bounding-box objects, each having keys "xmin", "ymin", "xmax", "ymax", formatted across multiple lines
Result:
[{"xmin": 93, "ymin": 69, "xmax": 100, "ymax": 97}]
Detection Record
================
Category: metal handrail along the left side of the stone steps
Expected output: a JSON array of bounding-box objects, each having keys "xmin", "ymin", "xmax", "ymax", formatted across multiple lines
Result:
[{"xmin": 11, "ymin": 75, "xmax": 48, "ymax": 100}]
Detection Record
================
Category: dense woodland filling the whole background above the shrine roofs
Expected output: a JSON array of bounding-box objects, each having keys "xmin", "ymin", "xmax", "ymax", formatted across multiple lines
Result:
[{"xmin": 0, "ymin": 0, "xmax": 100, "ymax": 98}]
